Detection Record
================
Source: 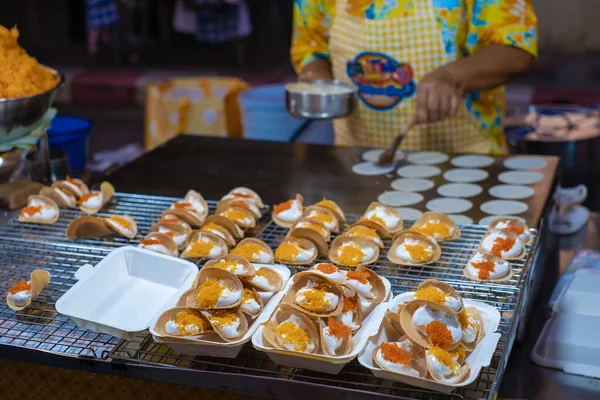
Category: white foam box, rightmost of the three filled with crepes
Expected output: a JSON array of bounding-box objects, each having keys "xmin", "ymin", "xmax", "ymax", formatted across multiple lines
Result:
[{"xmin": 358, "ymin": 292, "xmax": 500, "ymax": 393}]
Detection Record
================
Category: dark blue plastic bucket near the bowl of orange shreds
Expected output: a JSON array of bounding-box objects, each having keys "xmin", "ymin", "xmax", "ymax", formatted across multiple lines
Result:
[{"xmin": 48, "ymin": 115, "xmax": 92, "ymax": 171}]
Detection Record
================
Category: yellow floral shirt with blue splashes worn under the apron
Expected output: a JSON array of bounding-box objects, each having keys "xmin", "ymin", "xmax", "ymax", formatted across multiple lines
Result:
[{"xmin": 291, "ymin": 0, "xmax": 537, "ymax": 152}]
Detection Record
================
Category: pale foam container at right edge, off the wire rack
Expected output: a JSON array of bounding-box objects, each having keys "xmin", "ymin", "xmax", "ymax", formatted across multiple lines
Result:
[{"xmin": 531, "ymin": 269, "xmax": 600, "ymax": 378}]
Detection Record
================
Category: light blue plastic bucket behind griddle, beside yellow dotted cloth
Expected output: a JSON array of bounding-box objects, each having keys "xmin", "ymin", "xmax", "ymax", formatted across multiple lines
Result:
[{"xmin": 240, "ymin": 84, "xmax": 307, "ymax": 142}]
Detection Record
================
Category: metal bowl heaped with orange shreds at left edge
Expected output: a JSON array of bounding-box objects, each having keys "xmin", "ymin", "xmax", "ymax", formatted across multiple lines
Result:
[{"xmin": 0, "ymin": 68, "xmax": 65, "ymax": 143}]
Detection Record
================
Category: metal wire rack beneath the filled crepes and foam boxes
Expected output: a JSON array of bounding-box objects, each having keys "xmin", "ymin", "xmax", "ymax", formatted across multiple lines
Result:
[{"xmin": 0, "ymin": 193, "xmax": 537, "ymax": 399}]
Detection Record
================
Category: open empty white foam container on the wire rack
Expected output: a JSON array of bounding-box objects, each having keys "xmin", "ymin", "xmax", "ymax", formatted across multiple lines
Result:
[{"xmin": 56, "ymin": 246, "xmax": 198, "ymax": 340}]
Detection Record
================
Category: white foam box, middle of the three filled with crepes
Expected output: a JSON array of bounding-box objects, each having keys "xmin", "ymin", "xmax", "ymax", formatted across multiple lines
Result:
[{"xmin": 252, "ymin": 278, "xmax": 392, "ymax": 375}]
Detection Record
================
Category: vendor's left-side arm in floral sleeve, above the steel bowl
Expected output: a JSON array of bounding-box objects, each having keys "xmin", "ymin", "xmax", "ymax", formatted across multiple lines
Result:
[{"xmin": 291, "ymin": 0, "xmax": 335, "ymax": 80}]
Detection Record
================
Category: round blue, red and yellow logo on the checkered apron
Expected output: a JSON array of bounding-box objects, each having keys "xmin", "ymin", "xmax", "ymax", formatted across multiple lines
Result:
[{"xmin": 346, "ymin": 52, "xmax": 417, "ymax": 111}]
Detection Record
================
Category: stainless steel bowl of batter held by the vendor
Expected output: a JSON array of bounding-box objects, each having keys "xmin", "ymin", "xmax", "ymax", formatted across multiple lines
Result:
[{"xmin": 285, "ymin": 80, "xmax": 358, "ymax": 119}]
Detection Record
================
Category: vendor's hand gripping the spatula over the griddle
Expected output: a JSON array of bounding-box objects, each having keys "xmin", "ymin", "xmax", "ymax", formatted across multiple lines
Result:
[{"xmin": 415, "ymin": 66, "xmax": 463, "ymax": 124}]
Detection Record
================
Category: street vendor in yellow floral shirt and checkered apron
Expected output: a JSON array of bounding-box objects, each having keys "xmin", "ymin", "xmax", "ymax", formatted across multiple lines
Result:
[{"xmin": 291, "ymin": 0, "xmax": 537, "ymax": 154}]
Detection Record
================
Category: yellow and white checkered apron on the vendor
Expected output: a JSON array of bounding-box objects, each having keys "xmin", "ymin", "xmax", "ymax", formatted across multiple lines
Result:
[{"xmin": 329, "ymin": 0, "xmax": 493, "ymax": 153}]
